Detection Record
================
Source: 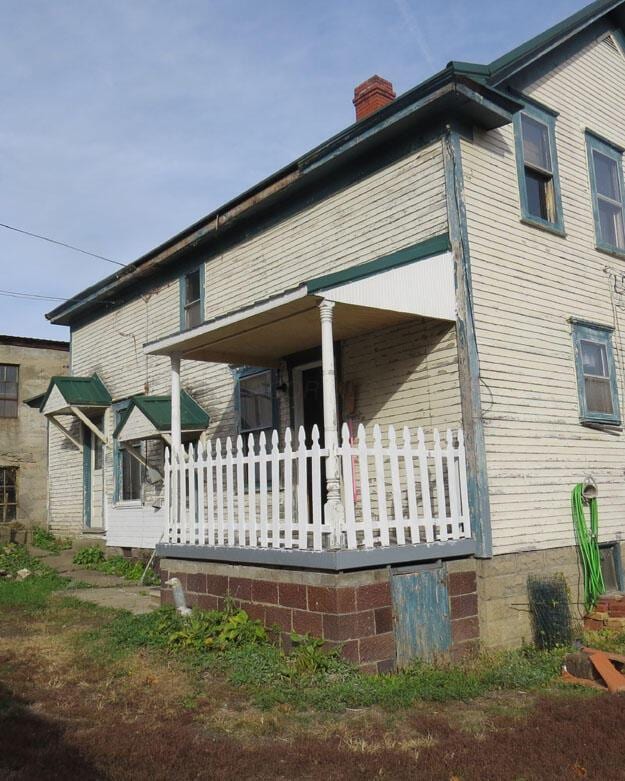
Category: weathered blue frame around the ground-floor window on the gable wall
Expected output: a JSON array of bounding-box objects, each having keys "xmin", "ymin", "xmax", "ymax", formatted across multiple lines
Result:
[{"xmin": 571, "ymin": 319, "xmax": 621, "ymax": 426}]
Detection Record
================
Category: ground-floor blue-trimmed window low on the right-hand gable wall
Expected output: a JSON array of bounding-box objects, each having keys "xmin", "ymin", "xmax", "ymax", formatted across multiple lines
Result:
[{"xmin": 573, "ymin": 322, "xmax": 621, "ymax": 425}]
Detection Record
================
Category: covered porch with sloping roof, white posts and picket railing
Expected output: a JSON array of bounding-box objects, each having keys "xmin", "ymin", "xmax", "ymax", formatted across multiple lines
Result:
[{"xmin": 146, "ymin": 236, "xmax": 474, "ymax": 569}]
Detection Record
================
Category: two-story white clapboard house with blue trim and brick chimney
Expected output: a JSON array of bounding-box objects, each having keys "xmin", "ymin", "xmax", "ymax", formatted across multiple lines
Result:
[{"xmin": 35, "ymin": 0, "xmax": 625, "ymax": 670}]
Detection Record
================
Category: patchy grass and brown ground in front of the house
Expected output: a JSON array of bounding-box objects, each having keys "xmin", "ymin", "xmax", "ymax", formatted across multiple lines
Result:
[{"xmin": 0, "ymin": 544, "xmax": 625, "ymax": 781}]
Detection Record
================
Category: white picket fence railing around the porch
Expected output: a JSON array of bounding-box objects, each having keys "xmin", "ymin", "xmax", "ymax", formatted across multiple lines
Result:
[{"xmin": 165, "ymin": 425, "xmax": 471, "ymax": 551}]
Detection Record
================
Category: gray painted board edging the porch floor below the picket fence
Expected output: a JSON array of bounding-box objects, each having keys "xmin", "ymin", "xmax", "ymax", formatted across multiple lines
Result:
[{"xmin": 156, "ymin": 540, "xmax": 476, "ymax": 572}]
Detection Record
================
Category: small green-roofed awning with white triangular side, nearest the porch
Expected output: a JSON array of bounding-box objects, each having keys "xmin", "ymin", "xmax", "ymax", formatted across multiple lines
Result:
[{"xmin": 113, "ymin": 391, "xmax": 210, "ymax": 442}]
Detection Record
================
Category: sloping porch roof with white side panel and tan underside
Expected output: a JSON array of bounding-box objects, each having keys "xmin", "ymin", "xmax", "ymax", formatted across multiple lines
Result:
[{"xmin": 144, "ymin": 234, "xmax": 456, "ymax": 366}]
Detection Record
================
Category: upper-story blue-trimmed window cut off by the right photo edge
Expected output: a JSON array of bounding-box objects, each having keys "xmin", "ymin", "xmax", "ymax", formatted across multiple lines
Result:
[{"xmin": 586, "ymin": 133, "xmax": 625, "ymax": 253}]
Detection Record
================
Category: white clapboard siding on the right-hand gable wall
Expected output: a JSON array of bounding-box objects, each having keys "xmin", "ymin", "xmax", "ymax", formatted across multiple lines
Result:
[{"xmin": 462, "ymin": 24, "xmax": 625, "ymax": 553}]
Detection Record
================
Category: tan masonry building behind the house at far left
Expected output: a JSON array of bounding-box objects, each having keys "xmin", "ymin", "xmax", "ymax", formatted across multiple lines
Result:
[{"xmin": 0, "ymin": 335, "xmax": 69, "ymax": 526}]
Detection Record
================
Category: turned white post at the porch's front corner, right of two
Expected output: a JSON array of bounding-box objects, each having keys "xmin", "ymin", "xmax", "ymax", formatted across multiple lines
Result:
[{"xmin": 319, "ymin": 300, "xmax": 345, "ymax": 547}]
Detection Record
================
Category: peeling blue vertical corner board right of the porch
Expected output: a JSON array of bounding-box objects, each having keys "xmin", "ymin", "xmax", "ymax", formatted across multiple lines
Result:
[{"xmin": 443, "ymin": 128, "xmax": 493, "ymax": 558}]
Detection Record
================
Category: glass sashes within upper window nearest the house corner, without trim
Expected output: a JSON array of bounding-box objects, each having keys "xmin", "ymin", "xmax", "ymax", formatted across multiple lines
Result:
[{"xmin": 521, "ymin": 114, "xmax": 557, "ymax": 223}]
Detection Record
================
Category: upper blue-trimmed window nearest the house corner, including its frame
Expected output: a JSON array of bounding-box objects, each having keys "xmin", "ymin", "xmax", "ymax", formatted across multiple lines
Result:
[{"xmin": 514, "ymin": 105, "xmax": 564, "ymax": 232}]
